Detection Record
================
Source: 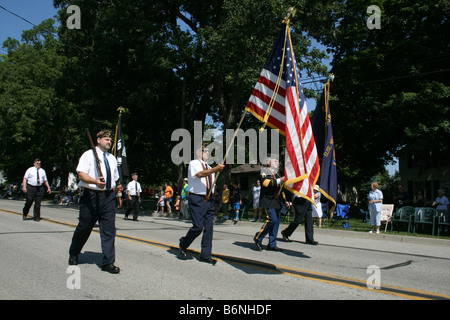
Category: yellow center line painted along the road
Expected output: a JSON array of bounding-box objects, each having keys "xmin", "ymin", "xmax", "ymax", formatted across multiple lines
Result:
[{"xmin": 0, "ymin": 208, "xmax": 450, "ymax": 300}]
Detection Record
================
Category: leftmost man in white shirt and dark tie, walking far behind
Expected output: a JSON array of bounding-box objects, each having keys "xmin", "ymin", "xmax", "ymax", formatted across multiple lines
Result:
[{"xmin": 22, "ymin": 159, "xmax": 52, "ymax": 221}]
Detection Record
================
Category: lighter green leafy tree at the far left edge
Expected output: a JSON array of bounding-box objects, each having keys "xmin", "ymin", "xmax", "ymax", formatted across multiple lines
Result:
[{"xmin": 0, "ymin": 19, "xmax": 79, "ymax": 182}]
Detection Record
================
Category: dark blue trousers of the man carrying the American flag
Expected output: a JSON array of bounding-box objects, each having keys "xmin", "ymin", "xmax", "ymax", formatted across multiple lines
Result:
[{"xmin": 180, "ymin": 193, "xmax": 215, "ymax": 259}]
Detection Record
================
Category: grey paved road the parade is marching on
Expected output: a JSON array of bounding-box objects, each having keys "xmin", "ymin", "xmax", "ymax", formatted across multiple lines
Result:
[{"xmin": 0, "ymin": 200, "xmax": 450, "ymax": 301}]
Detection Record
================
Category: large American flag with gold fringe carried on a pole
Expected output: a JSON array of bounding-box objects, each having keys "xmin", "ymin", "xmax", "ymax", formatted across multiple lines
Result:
[{"xmin": 245, "ymin": 24, "xmax": 320, "ymax": 203}]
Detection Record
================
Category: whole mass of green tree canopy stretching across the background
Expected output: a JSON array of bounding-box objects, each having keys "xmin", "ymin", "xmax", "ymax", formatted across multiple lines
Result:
[{"xmin": 0, "ymin": 0, "xmax": 450, "ymax": 192}]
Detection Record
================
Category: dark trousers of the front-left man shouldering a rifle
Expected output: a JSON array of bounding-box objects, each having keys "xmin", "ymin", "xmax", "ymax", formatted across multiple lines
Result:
[{"xmin": 69, "ymin": 189, "xmax": 116, "ymax": 265}]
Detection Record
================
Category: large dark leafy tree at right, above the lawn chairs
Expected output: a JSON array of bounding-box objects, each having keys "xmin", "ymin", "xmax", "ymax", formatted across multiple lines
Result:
[{"xmin": 324, "ymin": 0, "xmax": 450, "ymax": 184}]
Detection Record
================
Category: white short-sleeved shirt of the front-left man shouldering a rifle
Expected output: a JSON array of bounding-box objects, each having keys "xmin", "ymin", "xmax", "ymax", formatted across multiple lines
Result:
[{"xmin": 77, "ymin": 147, "xmax": 120, "ymax": 191}]
